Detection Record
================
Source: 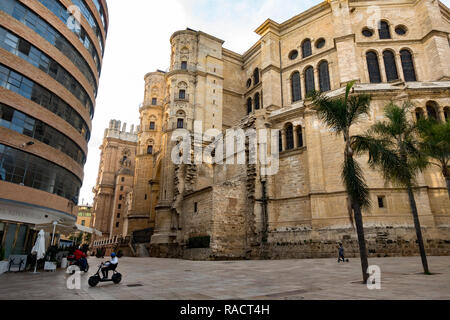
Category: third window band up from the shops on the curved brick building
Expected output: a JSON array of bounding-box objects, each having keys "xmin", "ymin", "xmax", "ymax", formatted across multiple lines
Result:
[{"xmin": 0, "ymin": 64, "xmax": 90, "ymax": 141}]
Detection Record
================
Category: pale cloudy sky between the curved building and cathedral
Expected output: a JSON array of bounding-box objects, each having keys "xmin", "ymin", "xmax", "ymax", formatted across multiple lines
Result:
[{"xmin": 79, "ymin": 0, "xmax": 450, "ymax": 204}]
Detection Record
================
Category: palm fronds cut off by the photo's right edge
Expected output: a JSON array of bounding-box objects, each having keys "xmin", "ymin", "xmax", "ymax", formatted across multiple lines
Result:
[{"xmin": 418, "ymin": 120, "xmax": 450, "ymax": 198}]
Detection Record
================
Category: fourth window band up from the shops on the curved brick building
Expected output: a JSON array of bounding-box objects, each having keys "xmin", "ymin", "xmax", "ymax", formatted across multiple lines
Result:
[{"xmin": 0, "ymin": 27, "xmax": 94, "ymax": 119}]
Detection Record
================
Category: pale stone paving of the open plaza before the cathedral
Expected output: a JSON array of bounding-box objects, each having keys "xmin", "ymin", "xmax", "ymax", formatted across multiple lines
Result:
[{"xmin": 0, "ymin": 257, "xmax": 450, "ymax": 300}]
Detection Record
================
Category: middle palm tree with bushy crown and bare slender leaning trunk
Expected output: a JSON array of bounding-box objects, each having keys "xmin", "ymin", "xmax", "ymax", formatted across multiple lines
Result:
[{"xmin": 352, "ymin": 102, "xmax": 430, "ymax": 274}]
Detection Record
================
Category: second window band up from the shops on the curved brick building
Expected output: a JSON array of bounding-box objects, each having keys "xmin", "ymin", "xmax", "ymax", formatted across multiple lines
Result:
[{"xmin": 0, "ymin": 103, "xmax": 86, "ymax": 166}]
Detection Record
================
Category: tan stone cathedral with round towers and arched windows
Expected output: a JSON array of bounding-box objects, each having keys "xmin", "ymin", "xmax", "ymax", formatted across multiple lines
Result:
[{"xmin": 93, "ymin": 0, "xmax": 450, "ymax": 260}]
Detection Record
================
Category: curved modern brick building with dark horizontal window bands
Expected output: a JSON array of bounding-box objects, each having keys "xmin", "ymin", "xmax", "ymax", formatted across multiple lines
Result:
[{"xmin": 0, "ymin": 0, "xmax": 109, "ymax": 257}]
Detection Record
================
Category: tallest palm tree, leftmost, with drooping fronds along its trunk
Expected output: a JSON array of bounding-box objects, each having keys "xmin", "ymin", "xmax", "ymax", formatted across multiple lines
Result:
[{"xmin": 312, "ymin": 82, "xmax": 371, "ymax": 283}]
